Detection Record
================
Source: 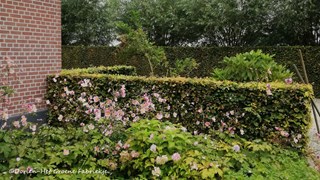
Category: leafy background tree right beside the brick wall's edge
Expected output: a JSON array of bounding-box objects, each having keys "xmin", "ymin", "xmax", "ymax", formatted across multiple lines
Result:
[{"xmin": 61, "ymin": 0, "xmax": 116, "ymax": 45}]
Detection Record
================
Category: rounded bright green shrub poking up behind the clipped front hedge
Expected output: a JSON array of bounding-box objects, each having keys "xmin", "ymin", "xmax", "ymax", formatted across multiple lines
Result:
[{"xmin": 212, "ymin": 50, "xmax": 293, "ymax": 82}]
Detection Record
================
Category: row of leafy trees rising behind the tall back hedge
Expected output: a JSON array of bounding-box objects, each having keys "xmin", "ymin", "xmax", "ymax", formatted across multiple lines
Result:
[{"xmin": 62, "ymin": 0, "xmax": 320, "ymax": 46}]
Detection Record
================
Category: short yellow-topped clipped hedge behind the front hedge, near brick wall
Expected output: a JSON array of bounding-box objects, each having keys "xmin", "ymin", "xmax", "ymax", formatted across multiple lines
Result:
[{"xmin": 62, "ymin": 66, "xmax": 137, "ymax": 76}]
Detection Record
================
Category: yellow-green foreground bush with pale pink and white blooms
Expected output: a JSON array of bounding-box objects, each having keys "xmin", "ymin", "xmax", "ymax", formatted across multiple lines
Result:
[{"xmin": 121, "ymin": 120, "xmax": 224, "ymax": 179}]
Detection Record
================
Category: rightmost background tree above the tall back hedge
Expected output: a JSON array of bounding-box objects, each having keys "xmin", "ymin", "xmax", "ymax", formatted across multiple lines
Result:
[{"xmin": 264, "ymin": 0, "xmax": 320, "ymax": 45}]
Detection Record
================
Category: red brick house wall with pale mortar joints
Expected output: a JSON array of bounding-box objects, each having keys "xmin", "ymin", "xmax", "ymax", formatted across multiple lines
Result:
[{"xmin": 0, "ymin": 0, "xmax": 61, "ymax": 116}]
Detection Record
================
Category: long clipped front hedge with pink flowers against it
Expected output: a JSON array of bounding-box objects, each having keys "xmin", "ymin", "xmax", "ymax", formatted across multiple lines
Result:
[{"xmin": 47, "ymin": 71, "xmax": 312, "ymax": 148}]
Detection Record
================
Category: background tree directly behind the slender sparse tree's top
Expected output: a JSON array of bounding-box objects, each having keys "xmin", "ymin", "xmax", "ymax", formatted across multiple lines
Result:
[{"xmin": 116, "ymin": 0, "xmax": 204, "ymax": 46}]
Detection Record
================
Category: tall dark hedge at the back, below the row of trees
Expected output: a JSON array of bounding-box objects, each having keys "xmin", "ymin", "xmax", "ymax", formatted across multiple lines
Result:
[{"xmin": 62, "ymin": 46, "xmax": 320, "ymax": 97}]
